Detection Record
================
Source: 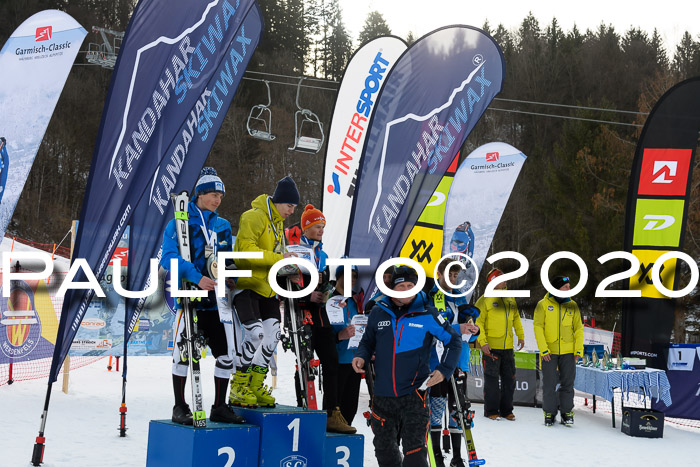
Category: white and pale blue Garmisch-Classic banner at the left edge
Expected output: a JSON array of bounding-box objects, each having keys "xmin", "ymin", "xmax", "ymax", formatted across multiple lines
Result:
[{"xmin": 0, "ymin": 10, "xmax": 87, "ymax": 241}]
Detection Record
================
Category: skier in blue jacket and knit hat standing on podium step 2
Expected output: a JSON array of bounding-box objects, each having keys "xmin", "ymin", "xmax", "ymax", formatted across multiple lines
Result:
[{"xmin": 160, "ymin": 167, "xmax": 244, "ymax": 425}]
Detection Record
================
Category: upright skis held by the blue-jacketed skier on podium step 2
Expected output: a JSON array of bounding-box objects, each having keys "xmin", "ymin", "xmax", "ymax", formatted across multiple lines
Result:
[{"xmin": 170, "ymin": 191, "xmax": 207, "ymax": 428}]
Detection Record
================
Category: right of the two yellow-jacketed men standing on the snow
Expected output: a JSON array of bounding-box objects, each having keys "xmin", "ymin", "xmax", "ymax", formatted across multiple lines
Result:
[{"xmin": 534, "ymin": 276, "xmax": 583, "ymax": 426}]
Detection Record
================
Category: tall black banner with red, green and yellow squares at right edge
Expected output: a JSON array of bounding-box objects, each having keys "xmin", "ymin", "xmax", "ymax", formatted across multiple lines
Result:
[{"xmin": 622, "ymin": 78, "xmax": 700, "ymax": 368}]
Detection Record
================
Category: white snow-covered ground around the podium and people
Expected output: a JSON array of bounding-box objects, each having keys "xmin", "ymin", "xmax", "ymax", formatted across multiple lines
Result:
[{"xmin": 0, "ymin": 349, "xmax": 700, "ymax": 467}]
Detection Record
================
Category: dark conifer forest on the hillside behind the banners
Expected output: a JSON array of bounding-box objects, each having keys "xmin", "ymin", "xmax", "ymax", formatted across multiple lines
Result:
[{"xmin": 0, "ymin": 0, "xmax": 700, "ymax": 341}]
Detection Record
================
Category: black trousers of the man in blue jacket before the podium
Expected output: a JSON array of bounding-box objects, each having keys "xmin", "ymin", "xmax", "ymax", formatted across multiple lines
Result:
[{"xmin": 371, "ymin": 391, "xmax": 430, "ymax": 467}]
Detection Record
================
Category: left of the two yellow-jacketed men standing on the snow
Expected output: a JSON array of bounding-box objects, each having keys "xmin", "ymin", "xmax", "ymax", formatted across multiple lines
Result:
[{"xmin": 476, "ymin": 269, "xmax": 525, "ymax": 421}]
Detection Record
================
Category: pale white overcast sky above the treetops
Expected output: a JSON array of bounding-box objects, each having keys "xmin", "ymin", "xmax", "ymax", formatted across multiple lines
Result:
[{"xmin": 340, "ymin": 0, "xmax": 700, "ymax": 53}]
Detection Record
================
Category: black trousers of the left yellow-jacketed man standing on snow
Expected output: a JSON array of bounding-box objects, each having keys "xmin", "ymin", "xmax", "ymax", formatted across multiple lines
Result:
[{"xmin": 484, "ymin": 349, "xmax": 515, "ymax": 417}]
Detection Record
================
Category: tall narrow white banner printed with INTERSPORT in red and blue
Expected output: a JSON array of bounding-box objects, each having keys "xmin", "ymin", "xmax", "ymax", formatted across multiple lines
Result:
[{"xmin": 323, "ymin": 36, "xmax": 407, "ymax": 264}]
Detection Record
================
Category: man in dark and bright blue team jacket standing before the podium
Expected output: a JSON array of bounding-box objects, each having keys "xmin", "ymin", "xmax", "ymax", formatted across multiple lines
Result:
[{"xmin": 352, "ymin": 266, "xmax": 462, "ymax": 467}]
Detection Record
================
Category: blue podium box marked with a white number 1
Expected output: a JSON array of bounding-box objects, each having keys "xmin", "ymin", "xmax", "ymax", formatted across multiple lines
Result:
[{"xmin": 236, "ymin": 405, "xmax": 326, "ymax": 467}]
